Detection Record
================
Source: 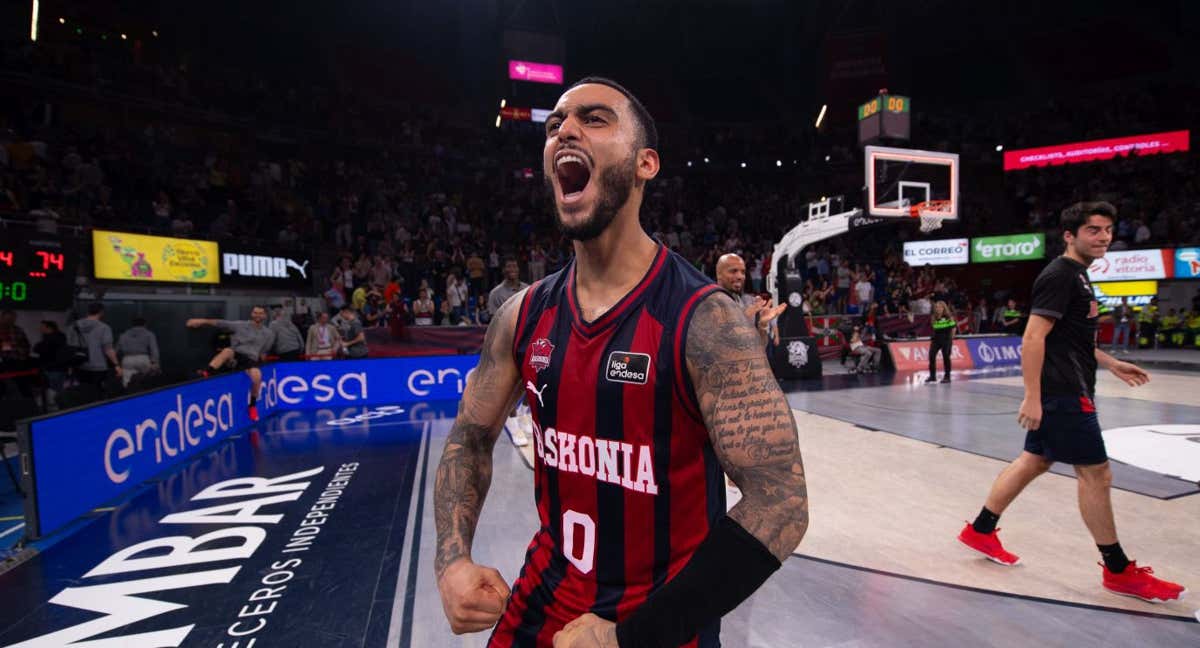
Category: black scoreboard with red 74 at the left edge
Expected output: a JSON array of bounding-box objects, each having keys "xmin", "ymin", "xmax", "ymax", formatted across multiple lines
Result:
[{"xmin": 0, "ymin": 228, "xmax": 79, "ymax": 311}]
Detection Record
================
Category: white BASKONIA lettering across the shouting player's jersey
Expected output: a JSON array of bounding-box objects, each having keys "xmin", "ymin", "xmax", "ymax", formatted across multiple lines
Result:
[{"xmin": 533, "ymin": 422, "xmax": 659, "ymax": 494}]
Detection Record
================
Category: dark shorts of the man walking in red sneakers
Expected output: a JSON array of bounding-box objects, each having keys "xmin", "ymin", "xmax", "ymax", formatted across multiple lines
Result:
[{"xmin": 1025, "ymin": 396, "xmax": 1109, "ymax": 466}]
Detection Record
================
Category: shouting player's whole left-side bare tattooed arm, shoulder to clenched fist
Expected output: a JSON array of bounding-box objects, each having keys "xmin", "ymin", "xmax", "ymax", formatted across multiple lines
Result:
[{"xmin": 433, "ymin": 292, "xmax": 524, "ymax": 632}]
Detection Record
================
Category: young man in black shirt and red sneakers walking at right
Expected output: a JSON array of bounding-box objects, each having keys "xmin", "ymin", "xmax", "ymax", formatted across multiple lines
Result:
[{"xmin": 959, "ymin": 203, "xmax": 1184, "ymax": 602}]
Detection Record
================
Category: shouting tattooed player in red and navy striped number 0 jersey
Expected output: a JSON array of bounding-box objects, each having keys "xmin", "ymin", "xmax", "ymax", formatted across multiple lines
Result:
[{"xmin": 434, "ymin": 78, "xmax": 808, "ymax": 648}]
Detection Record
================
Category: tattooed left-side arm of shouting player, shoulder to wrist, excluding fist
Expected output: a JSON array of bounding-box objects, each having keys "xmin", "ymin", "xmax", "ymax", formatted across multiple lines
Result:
[{"xmin": 433, "ymin": 292, "xmax": 524, "ymax": 577}]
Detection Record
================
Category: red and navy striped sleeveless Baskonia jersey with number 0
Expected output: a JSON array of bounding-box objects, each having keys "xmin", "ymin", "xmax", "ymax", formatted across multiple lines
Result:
[{"xmin": 488, "ymin": 246, "xmax": 726, "ymax": 648}]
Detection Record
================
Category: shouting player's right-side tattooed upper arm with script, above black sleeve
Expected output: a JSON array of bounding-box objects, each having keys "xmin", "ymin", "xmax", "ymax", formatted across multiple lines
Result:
[{"xmin": 686, "ymin": 294, "xmax": 809, "ymax": 562}]
